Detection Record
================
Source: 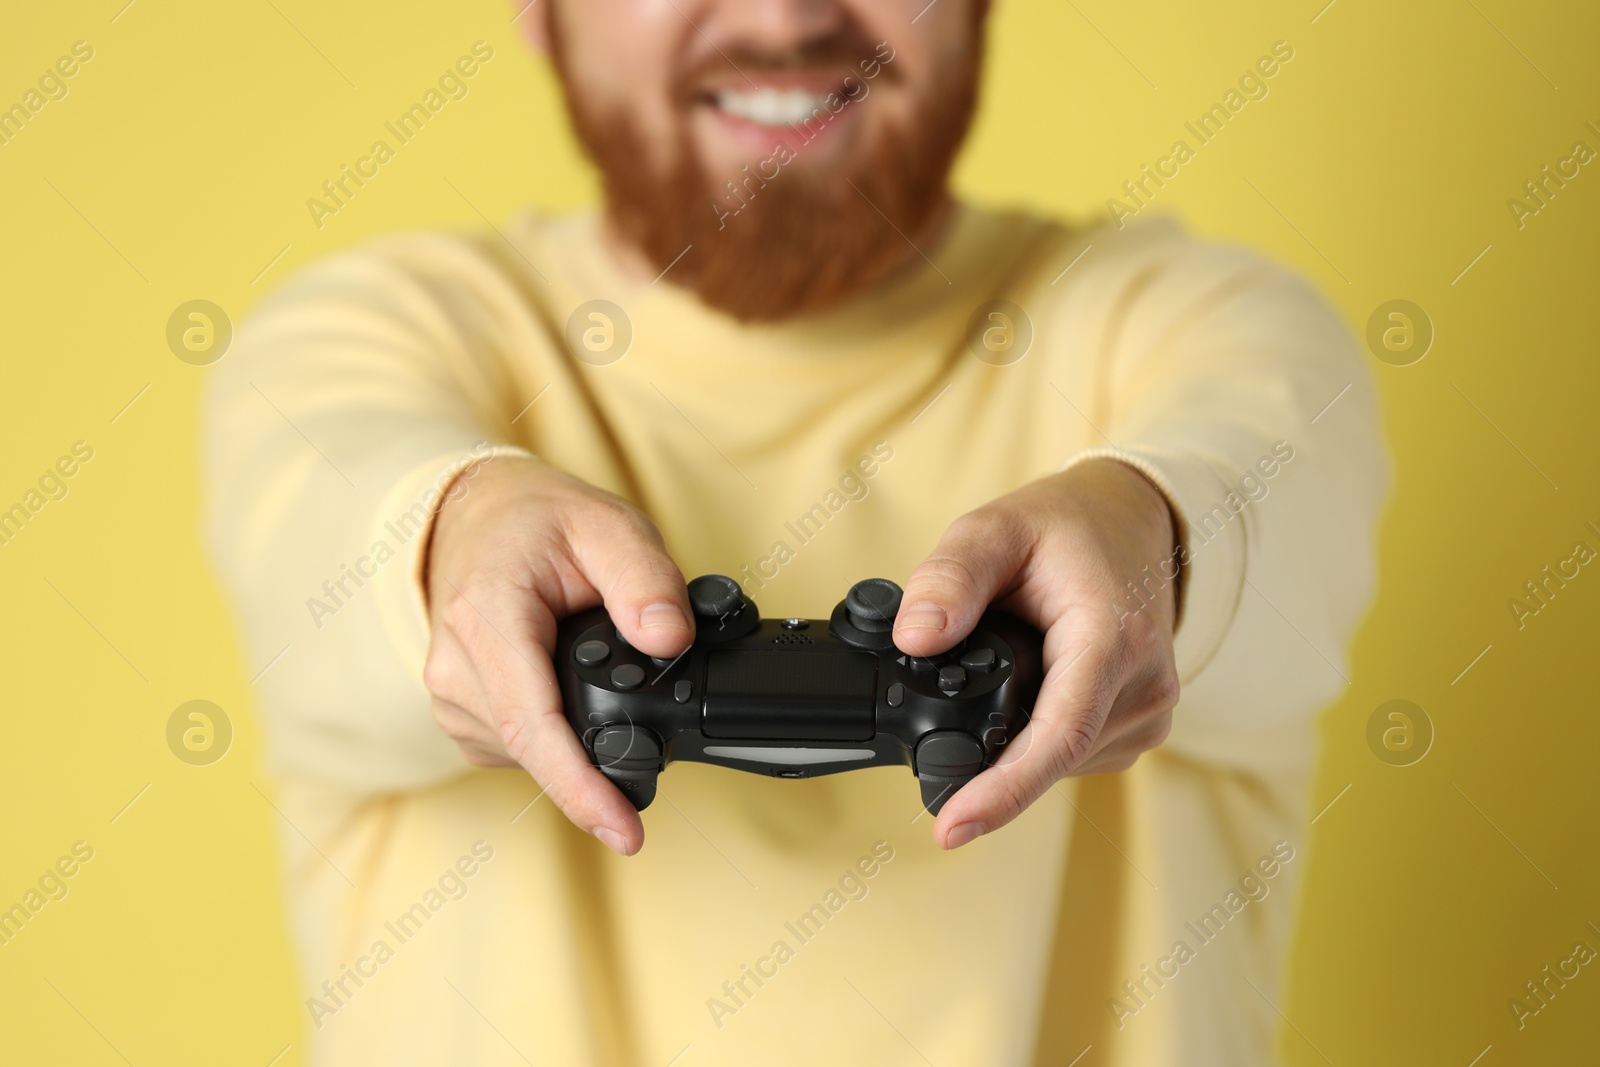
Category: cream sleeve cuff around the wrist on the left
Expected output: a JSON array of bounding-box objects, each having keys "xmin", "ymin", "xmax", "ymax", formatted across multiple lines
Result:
[{"xmin": 371, "ymin": 440, "xmax": 533, "ymax": 678}]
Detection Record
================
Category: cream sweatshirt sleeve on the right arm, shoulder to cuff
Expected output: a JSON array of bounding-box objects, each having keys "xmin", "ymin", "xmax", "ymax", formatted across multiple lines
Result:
[{"xmin": 1072, "ymin": 227, "xmax": 1389, "ymax": 768}]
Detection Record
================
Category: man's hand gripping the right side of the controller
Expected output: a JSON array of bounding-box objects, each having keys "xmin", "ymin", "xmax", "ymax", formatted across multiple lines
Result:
[{"xmin": 894, "ymin": 459, "xmax": 1178, "ymax": 848}]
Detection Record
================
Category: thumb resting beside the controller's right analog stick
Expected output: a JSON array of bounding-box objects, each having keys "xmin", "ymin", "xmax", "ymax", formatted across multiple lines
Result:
[{"xmin": 894, "ymin": 509, "xmax": 1032, "ymax": 656}]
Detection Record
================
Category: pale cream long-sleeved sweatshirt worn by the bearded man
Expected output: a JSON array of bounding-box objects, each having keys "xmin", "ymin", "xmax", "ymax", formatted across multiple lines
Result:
[{"xmin": 203, "ymin": 208, "xmax": 1387, "ymax": 1067}]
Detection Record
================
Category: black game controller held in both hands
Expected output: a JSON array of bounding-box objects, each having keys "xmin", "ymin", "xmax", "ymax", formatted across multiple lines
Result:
[{"xmin": 555, "ymin": 574, "xmax": 1043, "ymax": 814}]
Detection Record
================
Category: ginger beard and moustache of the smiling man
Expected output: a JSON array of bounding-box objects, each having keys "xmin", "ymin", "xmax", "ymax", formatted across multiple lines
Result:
[{"xmin": 550, "ymin": 14, "xmax": 982, "ymax": 322}]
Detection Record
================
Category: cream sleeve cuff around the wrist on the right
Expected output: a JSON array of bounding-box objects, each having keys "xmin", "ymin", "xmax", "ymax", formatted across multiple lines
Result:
[{"xmin": 1061, "ymin": 445, "xmax": 1248, "ymax": 683}]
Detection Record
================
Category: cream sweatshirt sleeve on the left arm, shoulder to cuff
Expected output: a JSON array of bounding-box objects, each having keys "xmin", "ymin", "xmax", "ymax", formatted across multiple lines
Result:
[{"xmin": 203, "ymin": 237, "xmax": 531, "ymax": 790}]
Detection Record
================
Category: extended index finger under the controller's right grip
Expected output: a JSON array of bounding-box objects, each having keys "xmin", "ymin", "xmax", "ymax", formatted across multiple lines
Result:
[{"xmin": 933, "ymin": 633, "xmax": 1117, "ymax": 848}]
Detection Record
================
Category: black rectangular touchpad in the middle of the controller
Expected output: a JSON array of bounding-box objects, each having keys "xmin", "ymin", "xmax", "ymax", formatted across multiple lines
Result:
[{"xmin": 702, "ymin": 648, "xmax": 878, "ymax": 741}]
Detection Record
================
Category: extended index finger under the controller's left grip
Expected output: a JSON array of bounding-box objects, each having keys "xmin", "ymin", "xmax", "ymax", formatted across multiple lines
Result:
[{"xmin": 446, "ymin": 595, "xmax": 645, "ymax": 856}]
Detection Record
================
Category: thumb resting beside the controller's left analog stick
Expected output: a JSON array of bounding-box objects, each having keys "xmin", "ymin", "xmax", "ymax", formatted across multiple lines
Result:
[{"xmin": 568, "ymin": 502, "xmax": 694, "ymax": 656}]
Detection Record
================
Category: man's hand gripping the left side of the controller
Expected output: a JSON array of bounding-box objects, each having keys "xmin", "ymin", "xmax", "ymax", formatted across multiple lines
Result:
[{"xmin": 422, "ymin": 456, "xmax": 694, "ymax": 856}]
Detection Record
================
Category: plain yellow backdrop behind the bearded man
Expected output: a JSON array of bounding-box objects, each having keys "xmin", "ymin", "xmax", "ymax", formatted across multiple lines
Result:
[{"xmin": 0, "ymin": 0, "xmax": 1600, "ymax": 1067}]
